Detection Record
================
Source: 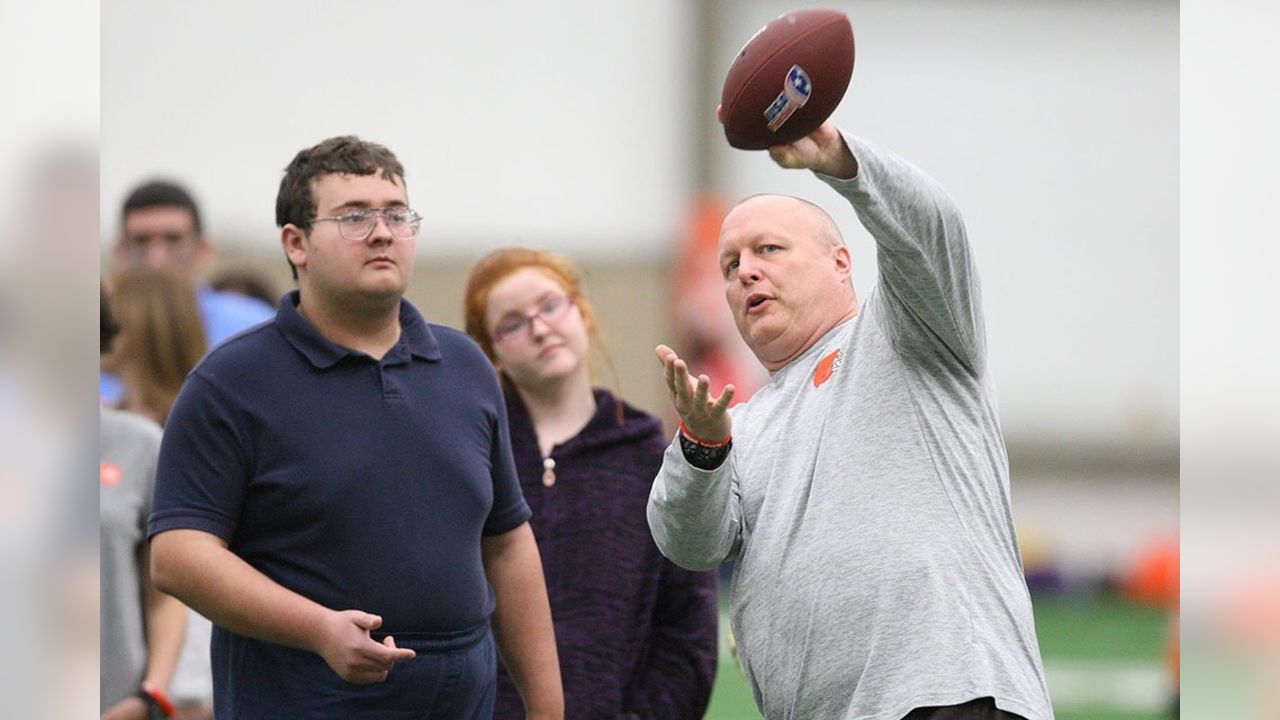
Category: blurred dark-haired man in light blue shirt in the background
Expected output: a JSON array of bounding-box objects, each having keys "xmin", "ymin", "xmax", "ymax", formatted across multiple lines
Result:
[{"xmin": 99, "ymin": 179, "xmax": 273, "ymax": 405}]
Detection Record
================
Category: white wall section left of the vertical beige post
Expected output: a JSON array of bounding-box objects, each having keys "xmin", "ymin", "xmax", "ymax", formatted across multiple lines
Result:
[{"xmin": 102, "ymin": 0, "xmax": 692, "ymax": 256}]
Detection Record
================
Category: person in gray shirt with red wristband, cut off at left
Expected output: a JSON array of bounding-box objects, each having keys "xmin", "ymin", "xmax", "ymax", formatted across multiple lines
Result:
[{"xmin": 99, "ymin": 284, "xmax": 187, "ymax": 720}]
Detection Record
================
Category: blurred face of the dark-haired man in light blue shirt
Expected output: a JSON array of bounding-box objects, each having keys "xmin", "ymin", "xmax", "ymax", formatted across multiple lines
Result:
[{"xmin": 115, "ymin": 205, "xmax": 212, "ymax": 282}]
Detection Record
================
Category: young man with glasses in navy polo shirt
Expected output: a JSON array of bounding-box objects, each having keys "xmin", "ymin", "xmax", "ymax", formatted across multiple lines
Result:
[{"xmin": 150, "ymin": 137, "xmax": 563, "ymax": 720}]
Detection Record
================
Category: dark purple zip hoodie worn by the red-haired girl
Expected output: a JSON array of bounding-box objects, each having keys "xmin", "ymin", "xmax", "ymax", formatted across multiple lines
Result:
[{"xmin": 493, "ymin": 389, "xmax": 718, "ymax": 720}]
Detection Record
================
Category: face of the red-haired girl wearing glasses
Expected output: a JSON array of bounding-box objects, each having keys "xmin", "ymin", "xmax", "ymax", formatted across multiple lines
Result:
[{"xmin": 485, "ymin": 268, "xmax": 590, "ymax": 389}]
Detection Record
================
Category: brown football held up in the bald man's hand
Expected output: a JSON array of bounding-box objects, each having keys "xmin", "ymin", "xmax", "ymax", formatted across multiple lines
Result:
[{"xmin": 721, "ymin": 9, "xmax": 854, "ymax": 150}]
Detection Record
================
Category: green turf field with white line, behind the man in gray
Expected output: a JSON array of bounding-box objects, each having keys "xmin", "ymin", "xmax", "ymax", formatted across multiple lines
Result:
[{"xmin": 705, "ymin": 594, "xmax": 1169, "ymax": 720}]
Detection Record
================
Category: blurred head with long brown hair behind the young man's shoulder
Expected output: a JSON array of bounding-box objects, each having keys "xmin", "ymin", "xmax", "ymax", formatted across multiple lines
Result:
[{"xmin": 104, "ymin": 266, "xmax": 205, "ymax": 425}]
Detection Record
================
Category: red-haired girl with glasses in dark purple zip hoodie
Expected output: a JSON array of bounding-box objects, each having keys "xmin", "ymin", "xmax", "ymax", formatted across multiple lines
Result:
[{"xmin": 465, "ymin": 247, "xmax": 718, "ymax": 720}]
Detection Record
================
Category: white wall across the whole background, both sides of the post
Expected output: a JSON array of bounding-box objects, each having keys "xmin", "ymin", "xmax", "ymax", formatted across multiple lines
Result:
[{"xmin": 101, "ymin": 0, "xmax": 1179, "ymax": 443}]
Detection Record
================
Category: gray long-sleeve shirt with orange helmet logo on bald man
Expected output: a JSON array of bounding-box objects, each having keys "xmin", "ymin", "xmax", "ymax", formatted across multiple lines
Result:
[{"xmin": 648, "ymin": 136, "xmax": 1053, "ymax": 720}]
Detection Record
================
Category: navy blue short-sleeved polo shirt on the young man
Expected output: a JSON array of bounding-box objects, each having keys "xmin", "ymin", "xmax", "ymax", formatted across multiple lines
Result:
[{"xmin": 148, "ymin": 291, "xmax": 530, "ymax": 638}]
